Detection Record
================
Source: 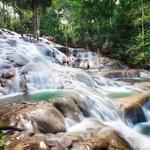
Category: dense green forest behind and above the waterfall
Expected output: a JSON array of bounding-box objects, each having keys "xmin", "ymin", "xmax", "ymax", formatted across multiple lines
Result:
[{"xmin": 0, "ymin": 0, "xmax": 150, "ymax": 68}]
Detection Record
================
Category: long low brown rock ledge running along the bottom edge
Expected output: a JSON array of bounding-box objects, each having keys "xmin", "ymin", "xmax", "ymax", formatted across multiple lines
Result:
[{"xmin": 5, "ymin": 130, "xmax": 133, "ymax": 150}]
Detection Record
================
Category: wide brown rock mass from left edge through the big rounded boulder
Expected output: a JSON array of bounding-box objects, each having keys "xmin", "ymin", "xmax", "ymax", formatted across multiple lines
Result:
[{"xmin": 0, "ymin": 104, "xmax": 65, "ymax": 133}]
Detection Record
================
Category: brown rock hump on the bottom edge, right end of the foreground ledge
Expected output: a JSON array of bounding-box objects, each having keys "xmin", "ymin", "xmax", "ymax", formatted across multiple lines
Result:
[{"xmin": 72, "ymin": 130, "xmax": 133, "ymax": 150}]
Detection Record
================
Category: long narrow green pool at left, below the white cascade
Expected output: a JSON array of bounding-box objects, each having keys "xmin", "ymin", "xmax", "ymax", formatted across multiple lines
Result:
[{"xmin": 0, "ymin": 90, "xmax": 64, "ymax": 106}]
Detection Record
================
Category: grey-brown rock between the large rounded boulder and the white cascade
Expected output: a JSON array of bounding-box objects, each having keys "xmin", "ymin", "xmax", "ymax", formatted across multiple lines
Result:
[{"xmin": 53, "ymin": 96, "xmax": 81, "ymax": 121}]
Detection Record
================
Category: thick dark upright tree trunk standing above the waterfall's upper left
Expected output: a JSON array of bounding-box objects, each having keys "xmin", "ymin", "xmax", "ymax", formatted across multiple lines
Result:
[{"xmin": 32, "ymin": 0, "xmax": 37, "ymax": 38}]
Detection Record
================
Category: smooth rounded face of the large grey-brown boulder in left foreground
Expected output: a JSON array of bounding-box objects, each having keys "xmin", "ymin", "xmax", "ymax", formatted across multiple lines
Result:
[{"xmin": 24, "ymin": 106, "xmax": 65, "ymax": 133}]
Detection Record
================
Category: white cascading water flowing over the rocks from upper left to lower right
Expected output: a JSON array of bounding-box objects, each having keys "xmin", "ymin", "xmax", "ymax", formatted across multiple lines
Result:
[{"xmin": 0, "ymin": 30, "xmax": 150, "ymax": 150}]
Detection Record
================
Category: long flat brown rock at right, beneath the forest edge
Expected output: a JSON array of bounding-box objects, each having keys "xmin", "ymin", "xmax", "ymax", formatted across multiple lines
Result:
[{"xmin": 102, "ymin": 69, "xmax": 139, "ymax": 78}]
